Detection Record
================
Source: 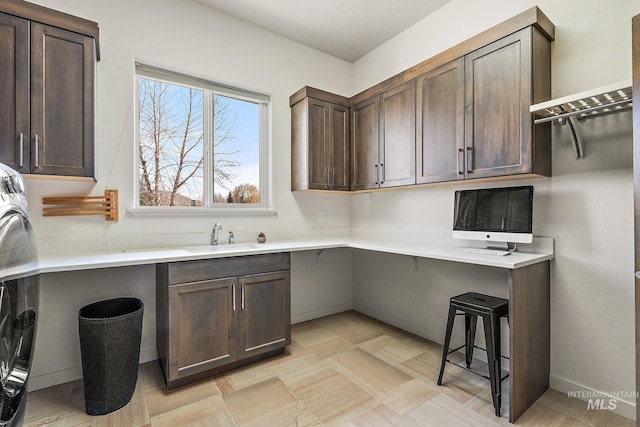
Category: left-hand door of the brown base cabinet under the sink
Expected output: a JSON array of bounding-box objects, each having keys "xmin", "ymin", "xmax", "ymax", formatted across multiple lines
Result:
[{"xmin": 167, "ymin": 278, "xmax": 239, "ymax": 381}]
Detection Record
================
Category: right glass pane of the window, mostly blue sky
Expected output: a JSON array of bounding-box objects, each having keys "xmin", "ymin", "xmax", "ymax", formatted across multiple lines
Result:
[{"xmin": 213, "ymin": 95, "xmax": 260, "ymax": 203}]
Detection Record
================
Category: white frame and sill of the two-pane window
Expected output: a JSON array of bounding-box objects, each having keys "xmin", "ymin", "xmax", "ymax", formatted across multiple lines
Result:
[{"xmin": 128, "ymin": 62, "xmax": 276, "ymax": 215}]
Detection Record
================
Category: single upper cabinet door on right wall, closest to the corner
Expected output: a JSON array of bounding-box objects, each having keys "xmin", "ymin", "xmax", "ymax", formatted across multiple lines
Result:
[{"xmin": 351, "ymin": 96, "xmax": 380, "ymax": 190}]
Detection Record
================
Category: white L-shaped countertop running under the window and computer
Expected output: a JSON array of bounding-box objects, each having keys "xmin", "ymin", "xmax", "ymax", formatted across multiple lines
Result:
[{"xmin": 39, "ymin": 237, "xmax": 554, "ymax": 273}]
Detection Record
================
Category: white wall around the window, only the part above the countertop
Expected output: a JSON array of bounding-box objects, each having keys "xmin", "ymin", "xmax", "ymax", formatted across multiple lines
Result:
[{"xmin": 27, "ymin": 0, "xmax": 352, "ymax": 248}]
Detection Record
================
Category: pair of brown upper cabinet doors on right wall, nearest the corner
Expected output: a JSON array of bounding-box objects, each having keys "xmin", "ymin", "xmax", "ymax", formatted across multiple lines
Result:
[{"xmin": 351, "ymin": 80, "xmax": 416, "ymax": 190}]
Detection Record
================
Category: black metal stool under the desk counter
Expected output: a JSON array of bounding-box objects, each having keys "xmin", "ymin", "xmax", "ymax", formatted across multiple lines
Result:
[{"xmin": 438, "ymin": 292, "xmax": 509, "ymax": 417}]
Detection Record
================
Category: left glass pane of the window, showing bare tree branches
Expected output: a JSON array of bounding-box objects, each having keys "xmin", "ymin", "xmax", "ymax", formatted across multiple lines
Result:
[{"xmin": 138, "ymin": 78, "xmax": 204, "ymax": 206}]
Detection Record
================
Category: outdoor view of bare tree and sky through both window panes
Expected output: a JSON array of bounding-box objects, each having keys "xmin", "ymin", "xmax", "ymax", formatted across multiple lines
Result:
[{"xmin": 138, "ymin": 77, "xmax": 260, "ymax": 206}]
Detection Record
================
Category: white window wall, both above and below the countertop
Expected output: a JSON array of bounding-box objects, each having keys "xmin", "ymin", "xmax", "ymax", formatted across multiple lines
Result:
[{"xmin": 27, "ymin": 0, "xmax": 352, "ymax": 389}]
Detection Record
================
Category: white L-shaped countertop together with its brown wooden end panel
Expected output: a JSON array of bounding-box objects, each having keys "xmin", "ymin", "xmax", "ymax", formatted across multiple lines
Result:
[{"xmin": 39, "ymin": 237, "xmax": 554, "ymax": 422}]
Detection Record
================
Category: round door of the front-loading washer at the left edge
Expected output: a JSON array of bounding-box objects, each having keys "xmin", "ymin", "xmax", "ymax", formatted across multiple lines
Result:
[{"xmin": 0, "ymin": 211, "xmax": 39, "ymax": 426}]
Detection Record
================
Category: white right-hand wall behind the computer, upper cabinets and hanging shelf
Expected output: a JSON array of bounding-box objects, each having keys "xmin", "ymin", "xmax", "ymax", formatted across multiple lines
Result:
[{"xmin": 352, "ymin": 0, "xmax": 640, "ymax": 418}]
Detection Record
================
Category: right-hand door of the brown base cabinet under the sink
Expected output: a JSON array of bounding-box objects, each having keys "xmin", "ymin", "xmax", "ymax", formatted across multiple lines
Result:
[{"xmin": 238, "ymin": 271, "xmax": 291, "ymax": 359}]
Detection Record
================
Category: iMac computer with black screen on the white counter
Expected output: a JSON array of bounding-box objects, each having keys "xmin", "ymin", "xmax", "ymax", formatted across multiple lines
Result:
[{"xmin": 453, "ymin": 185, "xmax": 533, "ymax": 250}]
